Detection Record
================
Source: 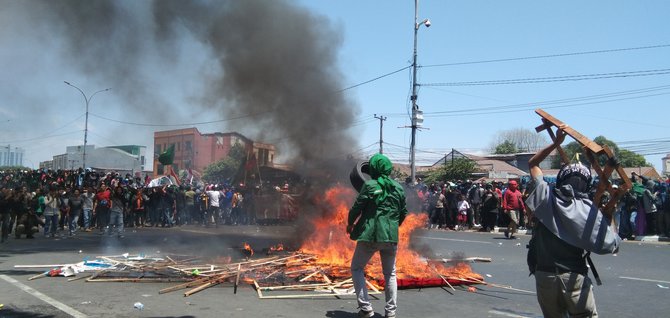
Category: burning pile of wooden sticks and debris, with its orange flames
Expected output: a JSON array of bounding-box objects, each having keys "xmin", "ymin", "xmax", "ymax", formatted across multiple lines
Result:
[{"xmin": 16, "ymin": 187, "xmax": 485, "ymax": 299}]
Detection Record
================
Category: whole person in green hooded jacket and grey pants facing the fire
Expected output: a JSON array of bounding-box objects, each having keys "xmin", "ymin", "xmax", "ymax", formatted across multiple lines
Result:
[{"xmin": 347, "ymin": 154, "xmax": 407, "ymax": 317}]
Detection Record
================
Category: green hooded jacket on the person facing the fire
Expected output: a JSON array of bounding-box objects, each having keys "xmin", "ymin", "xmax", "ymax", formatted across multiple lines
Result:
[{"xmin": 348, "ymin": 154, "xmax": 407, "ymax": 243}]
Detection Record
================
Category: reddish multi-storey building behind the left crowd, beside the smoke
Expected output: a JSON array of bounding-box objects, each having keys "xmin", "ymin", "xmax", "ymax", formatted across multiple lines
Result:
[{"xmin": 153, "ymin": 127, "xmax": 276, "ymax": 175}]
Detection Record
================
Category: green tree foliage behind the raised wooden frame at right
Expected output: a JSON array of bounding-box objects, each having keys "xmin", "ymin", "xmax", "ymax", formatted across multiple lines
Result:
[{"xmin": 551, "ymin": 136, "xmax": 650, "ymax": 169}]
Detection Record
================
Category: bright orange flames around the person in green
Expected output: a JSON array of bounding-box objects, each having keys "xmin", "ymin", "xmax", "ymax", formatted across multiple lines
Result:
[{"xmin": 300, "ymin": 186, "xmax": 482, "ymax": 282}]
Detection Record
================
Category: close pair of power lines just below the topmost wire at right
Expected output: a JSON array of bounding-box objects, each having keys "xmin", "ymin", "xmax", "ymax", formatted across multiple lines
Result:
[{"xmin": 420, "ymin": 69, "xmax": 670, "ymax": 86}]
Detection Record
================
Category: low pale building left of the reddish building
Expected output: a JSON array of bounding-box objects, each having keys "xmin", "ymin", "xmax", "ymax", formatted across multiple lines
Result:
[{"xmin": 50, "ymin": 145, "xmax": 147, "ymax": 173}]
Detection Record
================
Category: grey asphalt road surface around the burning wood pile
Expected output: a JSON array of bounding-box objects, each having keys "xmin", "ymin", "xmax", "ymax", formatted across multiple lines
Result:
[{"xmin": 0, "ymin": 226, "xmax": 670, "ymax": 318}]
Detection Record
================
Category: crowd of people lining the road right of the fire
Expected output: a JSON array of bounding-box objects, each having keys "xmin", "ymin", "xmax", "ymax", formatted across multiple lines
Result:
[{"xmin": 417, "ymin": 173, "xmax": 670, "ymax": 239}]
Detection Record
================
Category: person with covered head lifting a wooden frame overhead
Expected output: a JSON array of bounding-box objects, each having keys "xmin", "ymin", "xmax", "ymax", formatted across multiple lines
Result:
[{"xmin": 528, "ymin": 126, "xmax": 621, "ymax": 318}]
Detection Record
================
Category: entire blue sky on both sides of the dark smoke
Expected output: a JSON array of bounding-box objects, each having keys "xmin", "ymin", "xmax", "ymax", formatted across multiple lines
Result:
[{"xmin": 0, "ymin": 0, "xmax": 670, "ymax": 172}]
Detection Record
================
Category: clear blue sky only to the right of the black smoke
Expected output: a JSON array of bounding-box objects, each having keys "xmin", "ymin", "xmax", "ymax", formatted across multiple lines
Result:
[{"xmin": 302, "ymin": 0, "xmax": 670, "ymax": 170}]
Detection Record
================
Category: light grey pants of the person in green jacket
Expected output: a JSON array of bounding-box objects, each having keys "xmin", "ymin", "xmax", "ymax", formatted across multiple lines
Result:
[{"xmin": 351, "ymin": 242, "xmax": 398, "ymax": 316}]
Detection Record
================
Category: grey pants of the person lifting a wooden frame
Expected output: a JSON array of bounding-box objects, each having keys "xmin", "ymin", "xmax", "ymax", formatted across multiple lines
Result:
[{"xmin": 535, "ymin": 271, "xmax": 598, "ymax": 318}]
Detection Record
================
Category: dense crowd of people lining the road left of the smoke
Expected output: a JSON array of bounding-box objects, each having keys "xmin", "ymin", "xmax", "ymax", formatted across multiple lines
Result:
[{"xmin": 0, "ymin": 170, "xmax": 262, "ymax": 242}]
